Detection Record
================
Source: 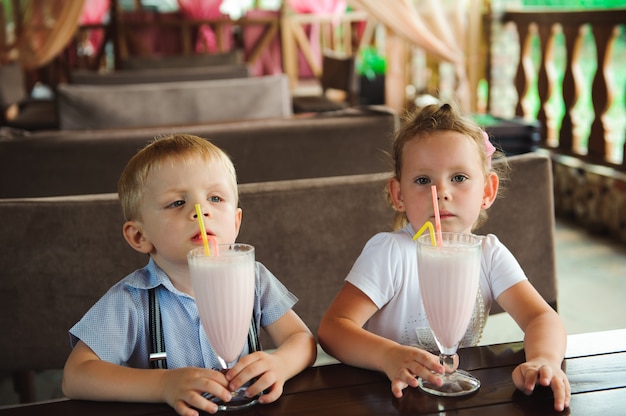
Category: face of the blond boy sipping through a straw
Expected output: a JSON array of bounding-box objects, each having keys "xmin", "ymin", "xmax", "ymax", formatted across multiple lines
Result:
[{"xmin": 127, "ymin": 157, "xmax": 241, "ymax": 272}]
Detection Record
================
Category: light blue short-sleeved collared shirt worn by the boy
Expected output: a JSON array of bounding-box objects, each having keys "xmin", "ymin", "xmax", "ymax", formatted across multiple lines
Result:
[{"xmin": 69, "ymin": 259, "xmax": 298, "ymax": 368}]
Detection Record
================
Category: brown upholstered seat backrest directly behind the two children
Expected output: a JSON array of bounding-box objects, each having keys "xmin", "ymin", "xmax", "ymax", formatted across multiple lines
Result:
[{"xmin": 0, "ymin": 154, "xmax": 557, "ymax": 370}]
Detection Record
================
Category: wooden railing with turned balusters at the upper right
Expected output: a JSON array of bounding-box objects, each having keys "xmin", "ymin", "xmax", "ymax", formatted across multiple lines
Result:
[{"xmin": 501, "ymin": 9, "xmax": 626, "ymax": 170}]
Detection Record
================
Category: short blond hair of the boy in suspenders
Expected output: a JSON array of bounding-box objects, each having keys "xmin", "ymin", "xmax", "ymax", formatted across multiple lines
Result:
[{"xmin": 117, "ymin": 134, "xmax": 239, "ymax": 221}]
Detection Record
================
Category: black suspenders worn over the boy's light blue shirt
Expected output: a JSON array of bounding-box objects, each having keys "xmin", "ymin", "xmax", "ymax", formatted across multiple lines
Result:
[{"xmin": 148, "ymin": 287, "xmax": 261, "ymax": 368}]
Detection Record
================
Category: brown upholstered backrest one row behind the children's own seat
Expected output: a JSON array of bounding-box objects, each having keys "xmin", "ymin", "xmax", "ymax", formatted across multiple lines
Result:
[{"xmin": 0, "ymin": 108, "xmax": 398, "ymax": 198}]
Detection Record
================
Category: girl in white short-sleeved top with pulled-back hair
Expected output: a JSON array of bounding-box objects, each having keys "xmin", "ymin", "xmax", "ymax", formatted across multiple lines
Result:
[{"xmin": 318, "ymin": 104, "xmax": 570, "ymax": 411}]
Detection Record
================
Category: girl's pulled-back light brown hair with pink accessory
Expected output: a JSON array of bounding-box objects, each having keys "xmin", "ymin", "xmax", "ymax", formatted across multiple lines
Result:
[{"xmin": 386, "ymin": 103, "xmax": 509, "ymax": 230}]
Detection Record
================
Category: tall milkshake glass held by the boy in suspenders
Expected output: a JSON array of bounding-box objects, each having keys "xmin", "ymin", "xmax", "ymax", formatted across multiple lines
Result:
[{"xmin": 187, "ymin": 243, "xmax": 256, "ymax": 410}]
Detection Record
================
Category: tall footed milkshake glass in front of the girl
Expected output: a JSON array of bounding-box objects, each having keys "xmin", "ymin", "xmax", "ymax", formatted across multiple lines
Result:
[{"xmin": 417, "ymin": 232, "xmax": 482, "ymax": 396}]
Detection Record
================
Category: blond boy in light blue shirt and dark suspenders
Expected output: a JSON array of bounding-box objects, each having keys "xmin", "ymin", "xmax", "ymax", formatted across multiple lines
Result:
[{"xmin": 63, "ymin": 135, "xmax": 316, "ymax": 416}]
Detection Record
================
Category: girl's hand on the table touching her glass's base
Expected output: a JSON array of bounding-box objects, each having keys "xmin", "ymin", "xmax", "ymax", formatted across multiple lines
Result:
[{"xmin": 383, "ymin": 345, "xmax": 444, "ymax": 398}]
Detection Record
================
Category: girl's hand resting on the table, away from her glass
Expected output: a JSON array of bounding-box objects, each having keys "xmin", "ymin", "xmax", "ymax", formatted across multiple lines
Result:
[{"xmin": 512, "ymin": 359, "xmax": 571, "ymax": 412}]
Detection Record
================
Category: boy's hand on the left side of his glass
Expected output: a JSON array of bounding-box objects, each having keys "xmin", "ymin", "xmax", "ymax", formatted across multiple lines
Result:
[{"xmin": 161, "ymin": 367, "xmax": 231, "ymax": 416}]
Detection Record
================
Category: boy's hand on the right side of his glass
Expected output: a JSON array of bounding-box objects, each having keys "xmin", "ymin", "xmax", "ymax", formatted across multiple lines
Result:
[{"xmin": 226, "ymin": 351, "xmax": 287, "ymax": 403}]
